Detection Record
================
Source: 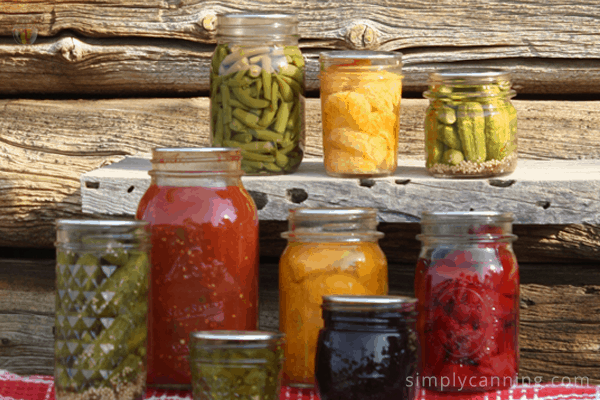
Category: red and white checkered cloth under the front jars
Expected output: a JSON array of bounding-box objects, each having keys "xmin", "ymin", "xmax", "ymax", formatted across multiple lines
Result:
[{"xmin": 0, "ymin": 370, "xmax": 600, "ymax": 400}]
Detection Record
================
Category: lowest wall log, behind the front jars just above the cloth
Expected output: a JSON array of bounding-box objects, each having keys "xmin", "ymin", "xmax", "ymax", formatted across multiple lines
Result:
[{"xmin": 0, "ymin": 259, "xmax": 600, "ymax": 384}]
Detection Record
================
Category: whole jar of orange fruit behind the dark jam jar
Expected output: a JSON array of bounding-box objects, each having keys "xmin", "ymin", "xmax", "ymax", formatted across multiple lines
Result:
[{"xmin": 279, "ymin": 208, "xmax": 388, "ymax": 387}]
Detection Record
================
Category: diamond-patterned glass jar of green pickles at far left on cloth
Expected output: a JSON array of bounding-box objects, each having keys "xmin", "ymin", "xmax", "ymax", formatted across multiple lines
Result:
[{"xmin": 54, "ymin": 219, "xmax": 150, "ymax": 400}]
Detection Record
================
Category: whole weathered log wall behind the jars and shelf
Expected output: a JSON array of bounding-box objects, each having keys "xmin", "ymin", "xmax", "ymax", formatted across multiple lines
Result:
[{"xmin": 0, "ymin": 0, "xmax": 600, "ymax": 383}]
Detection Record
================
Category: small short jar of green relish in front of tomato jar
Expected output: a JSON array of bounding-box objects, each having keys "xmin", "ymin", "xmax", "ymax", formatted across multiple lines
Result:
[{"xmin": 190, "ymin": 331, "xmax": 284, "ymax": 400}]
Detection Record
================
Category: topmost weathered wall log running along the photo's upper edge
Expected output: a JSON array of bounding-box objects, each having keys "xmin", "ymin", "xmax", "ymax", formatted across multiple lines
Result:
[{"xmin": 0, "ymin": 0, "xmax": 600, "ymax": 59}]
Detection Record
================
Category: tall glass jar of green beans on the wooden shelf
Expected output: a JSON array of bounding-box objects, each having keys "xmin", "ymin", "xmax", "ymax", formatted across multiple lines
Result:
[{"xmin": 210, "ymin": 14, "xmax": 304, "ymax": 175}]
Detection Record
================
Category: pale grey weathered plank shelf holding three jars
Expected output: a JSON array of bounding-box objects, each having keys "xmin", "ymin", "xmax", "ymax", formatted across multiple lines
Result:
[{"xmin": 81, "ymin": 158, "xmax": 600, "ymax": 224}]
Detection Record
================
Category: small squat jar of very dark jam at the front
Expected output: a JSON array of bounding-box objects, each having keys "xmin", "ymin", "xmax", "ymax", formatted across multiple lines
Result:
[{"xmin": 315, "ymin": 296, "xmax": 419, "ymax": 400}]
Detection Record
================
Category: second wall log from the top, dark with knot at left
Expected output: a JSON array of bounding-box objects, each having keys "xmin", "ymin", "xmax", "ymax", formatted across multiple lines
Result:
[{"xmin": 0, "ymin": 35, "xmax": 600, "ymax": 96}]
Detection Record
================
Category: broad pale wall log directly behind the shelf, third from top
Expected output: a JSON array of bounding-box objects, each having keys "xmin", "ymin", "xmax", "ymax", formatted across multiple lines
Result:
[{"xmin": 0, "ymin": 98, "xmax": 600, "ymax": 247}]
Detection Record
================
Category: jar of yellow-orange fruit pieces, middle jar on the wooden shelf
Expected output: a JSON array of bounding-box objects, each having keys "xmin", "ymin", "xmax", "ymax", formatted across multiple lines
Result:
[{"xmin": 319, "ymin": 51, "xmax": 402, "ymax": 178}]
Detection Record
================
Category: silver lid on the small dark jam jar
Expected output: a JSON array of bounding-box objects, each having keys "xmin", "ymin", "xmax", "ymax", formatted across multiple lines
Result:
[{"xmin": 322, "ymin": 295, "xmax": 417, "ymax": 311}]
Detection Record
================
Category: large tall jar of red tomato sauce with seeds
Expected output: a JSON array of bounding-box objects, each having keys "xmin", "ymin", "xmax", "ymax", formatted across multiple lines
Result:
[{"xmin": 136, "ymin": 148, "xmax": 259, "ymax": 388}]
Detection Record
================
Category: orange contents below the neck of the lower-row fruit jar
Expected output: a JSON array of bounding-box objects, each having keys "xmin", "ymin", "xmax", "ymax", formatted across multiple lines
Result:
[{"xmin": 279, "ymin": 242, "xmax": 388, "ymax": 386}]
